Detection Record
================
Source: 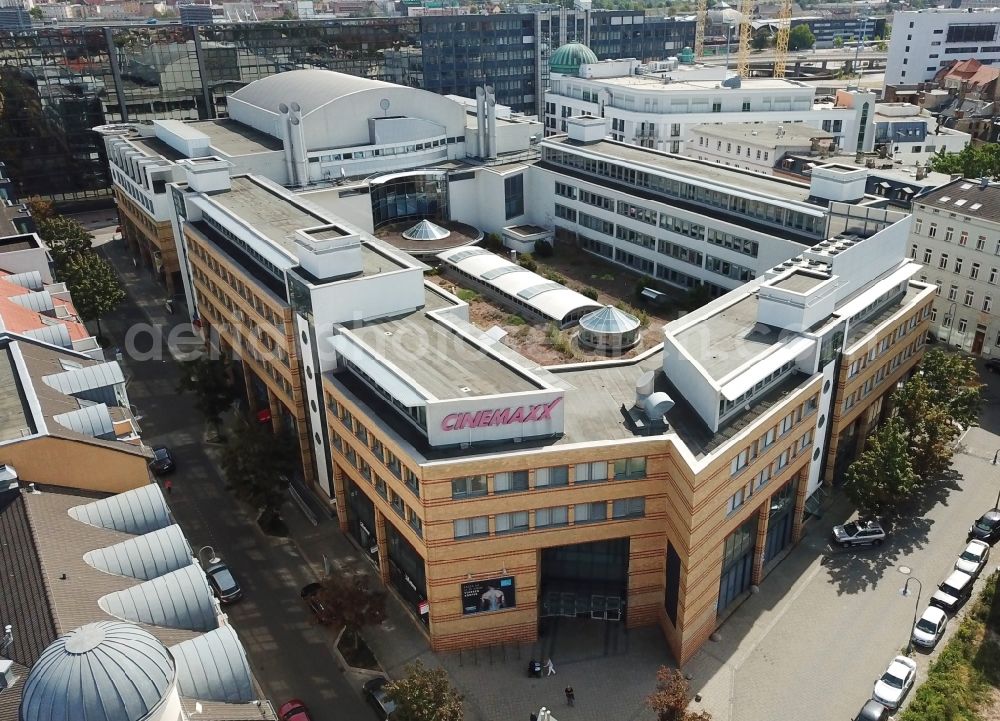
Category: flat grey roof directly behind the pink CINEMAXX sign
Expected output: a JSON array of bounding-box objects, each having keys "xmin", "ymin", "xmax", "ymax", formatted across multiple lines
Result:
[{"xmin": 351, "ymin": 285, "xmax": 541, "ymax": 400}]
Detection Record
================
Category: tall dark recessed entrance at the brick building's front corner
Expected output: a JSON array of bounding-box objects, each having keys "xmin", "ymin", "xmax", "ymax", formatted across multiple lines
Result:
[{"xmin": 539, "ymin": 538, "xmax": 629, "ymax": 621}]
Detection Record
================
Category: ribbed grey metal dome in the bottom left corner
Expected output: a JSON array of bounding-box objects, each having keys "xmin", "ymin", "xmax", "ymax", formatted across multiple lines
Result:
[{"xmin": 19, "ymin": 621, "xmax": 175, "ymax": 721}]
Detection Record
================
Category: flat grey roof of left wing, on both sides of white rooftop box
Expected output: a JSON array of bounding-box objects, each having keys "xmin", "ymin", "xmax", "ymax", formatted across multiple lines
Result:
[{"xmin": 208, "ymin": 175, "xmax": 405, "ymax": 275}]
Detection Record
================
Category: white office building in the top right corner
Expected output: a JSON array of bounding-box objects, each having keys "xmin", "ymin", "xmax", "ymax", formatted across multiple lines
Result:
[{"xmin": 885, "ymin": 8, "xmax": 1000, "ymax": 85}]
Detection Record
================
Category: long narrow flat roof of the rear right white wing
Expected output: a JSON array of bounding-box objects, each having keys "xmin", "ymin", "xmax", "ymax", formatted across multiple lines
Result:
[{"xmin": 545, "ymin": 136, "xmax": 810, "ymax": 205}]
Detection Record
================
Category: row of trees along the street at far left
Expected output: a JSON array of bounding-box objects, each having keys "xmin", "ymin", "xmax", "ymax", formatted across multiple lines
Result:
[{"xmin": 28, "ymin": 200, "xmax": 125, "ymax": 336}]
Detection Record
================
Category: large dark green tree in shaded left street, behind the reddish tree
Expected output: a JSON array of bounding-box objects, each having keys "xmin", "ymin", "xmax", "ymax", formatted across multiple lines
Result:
[{"xmin": 222, "ymin": 423, "xmax": 297, "ymax": 531}]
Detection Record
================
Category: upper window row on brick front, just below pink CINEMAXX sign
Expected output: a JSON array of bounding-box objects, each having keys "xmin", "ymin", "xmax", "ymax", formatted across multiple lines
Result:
[{"xmin": 451, "ymin": 457, "xmax": 646, "ymax": 500}]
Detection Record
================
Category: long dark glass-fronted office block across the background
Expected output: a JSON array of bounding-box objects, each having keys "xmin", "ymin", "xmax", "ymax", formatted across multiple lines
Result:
[{"xmin": 0, "ymin": 11, "xmax": 694, "ymax": 202}]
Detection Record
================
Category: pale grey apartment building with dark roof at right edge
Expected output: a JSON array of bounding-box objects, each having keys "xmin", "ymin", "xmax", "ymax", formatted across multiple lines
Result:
[{"xmin": 909, "ymin": 178, "xmax": 1000, "ymax": 356}]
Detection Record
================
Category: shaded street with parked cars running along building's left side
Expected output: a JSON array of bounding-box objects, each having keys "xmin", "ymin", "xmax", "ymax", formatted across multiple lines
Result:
[{"xmin": 102, "ymin": 236, "xmax": 374, "ymax": 721}]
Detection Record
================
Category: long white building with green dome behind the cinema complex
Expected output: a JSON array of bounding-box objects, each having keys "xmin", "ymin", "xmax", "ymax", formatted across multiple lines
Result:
[{"xmin": 544, "ymin": 54, "xmax": 876, "ymax": 153}]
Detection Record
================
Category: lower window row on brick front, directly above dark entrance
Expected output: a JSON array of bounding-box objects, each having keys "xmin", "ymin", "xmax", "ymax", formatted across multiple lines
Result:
[{"xmin": 453, "ymin": 496, "xmax": 646, "ymax": 540}]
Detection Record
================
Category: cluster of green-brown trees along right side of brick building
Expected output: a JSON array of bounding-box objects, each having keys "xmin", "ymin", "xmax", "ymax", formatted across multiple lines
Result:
[{"xmin": 844, "ymin": 348, "xmax": 983, "ymax": 516}]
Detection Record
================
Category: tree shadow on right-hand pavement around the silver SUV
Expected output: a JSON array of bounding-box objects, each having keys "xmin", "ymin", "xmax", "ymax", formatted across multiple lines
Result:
[{"xmin": 821, "ymin": 469, "xmax": 962, "ymax": 595}]
